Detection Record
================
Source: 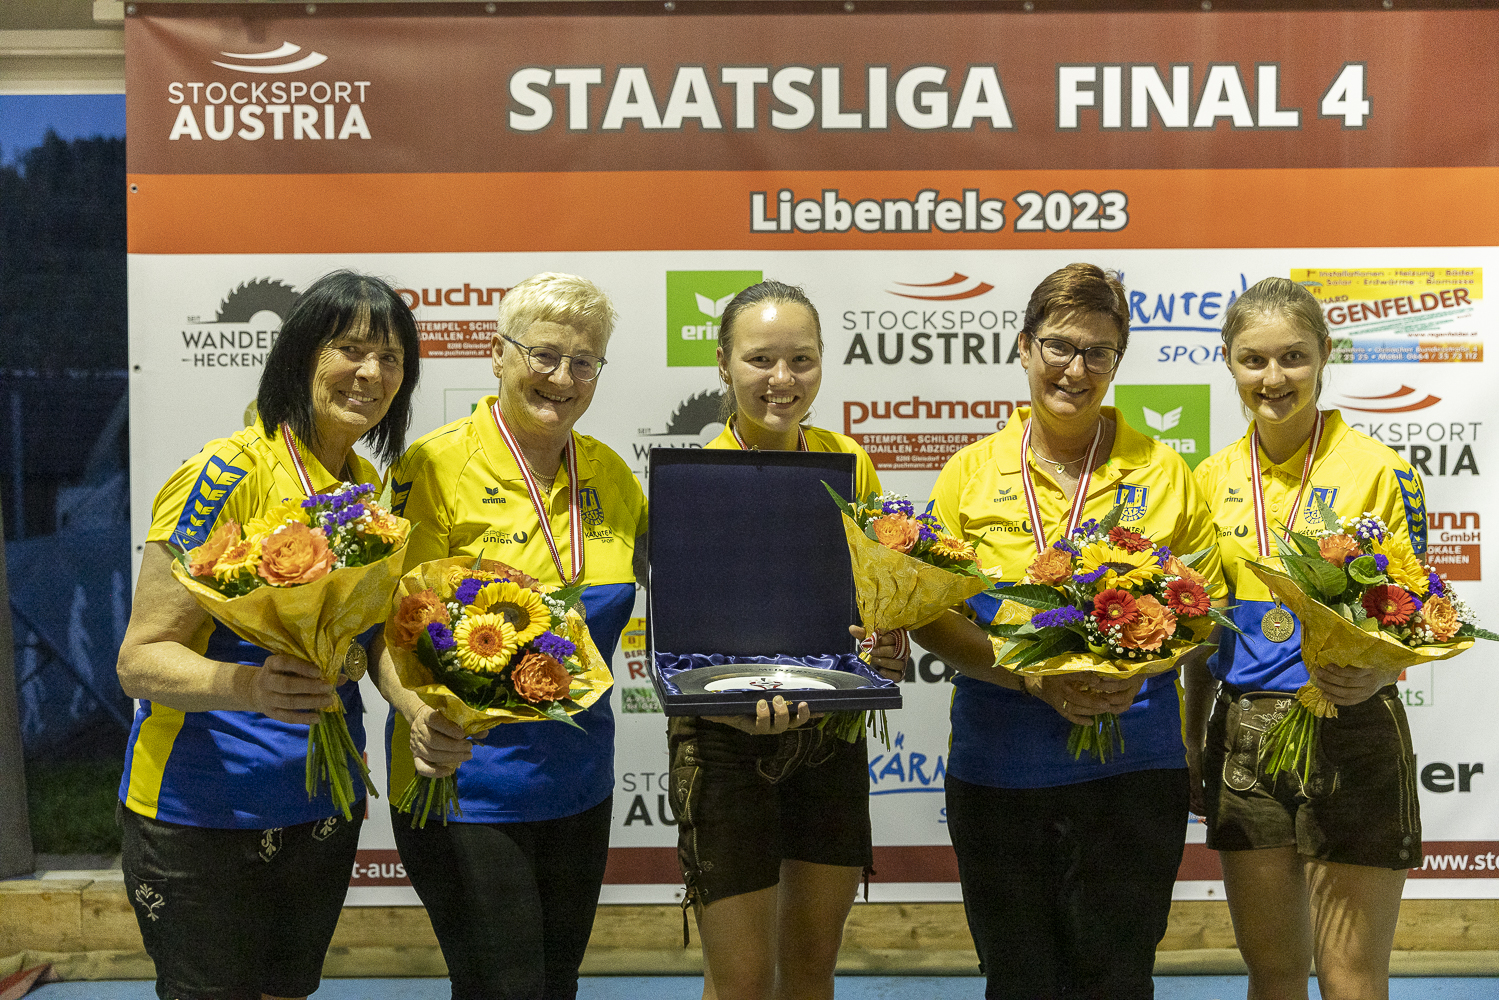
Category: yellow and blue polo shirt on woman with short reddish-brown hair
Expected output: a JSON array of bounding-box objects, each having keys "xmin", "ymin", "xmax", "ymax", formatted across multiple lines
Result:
[{"xmin": 932, "ymin": 406, "xmax": 1228, "ymax": 789}]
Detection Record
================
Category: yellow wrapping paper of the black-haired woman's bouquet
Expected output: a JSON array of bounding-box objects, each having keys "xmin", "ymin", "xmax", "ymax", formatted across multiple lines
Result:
[{"xmin": 172, "ymin": 544, "xmax": 406, "ymax": 689}]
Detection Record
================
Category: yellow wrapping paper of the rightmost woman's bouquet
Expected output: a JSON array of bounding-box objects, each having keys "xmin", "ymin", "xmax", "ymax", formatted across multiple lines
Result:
[{"xmin": 1249, "ymin": 562, "xmax": 1474, "ymax": 718}]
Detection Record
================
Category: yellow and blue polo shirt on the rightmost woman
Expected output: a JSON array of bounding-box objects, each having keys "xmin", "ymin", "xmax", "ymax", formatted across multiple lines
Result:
[{"xmin": 1196, "ymin": 409, "xmax": 1427, "ymax": 691}]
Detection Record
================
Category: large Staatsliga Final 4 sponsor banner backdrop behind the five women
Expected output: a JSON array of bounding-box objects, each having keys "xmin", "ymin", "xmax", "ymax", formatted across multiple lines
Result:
[{"xmin": 126, "ymin": 3, "xmax": 1499, "ymax": 903}]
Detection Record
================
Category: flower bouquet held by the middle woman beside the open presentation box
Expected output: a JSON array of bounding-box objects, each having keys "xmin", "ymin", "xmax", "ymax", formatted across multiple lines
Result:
[{"xmin": 820, "ymin": 483, "xmax": 994, "ymax": 745}]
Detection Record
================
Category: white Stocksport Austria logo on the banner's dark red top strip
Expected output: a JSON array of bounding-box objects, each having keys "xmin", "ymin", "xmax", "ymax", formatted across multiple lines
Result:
[{"xmin": 166, "ymin": 42, "xmax": 372, "ymax": 142}]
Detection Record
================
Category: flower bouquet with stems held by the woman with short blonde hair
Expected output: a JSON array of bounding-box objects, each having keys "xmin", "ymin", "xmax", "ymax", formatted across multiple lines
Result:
[{"xmin": 385, "ymin": 556, "xmax": 615, "ymax": 828}]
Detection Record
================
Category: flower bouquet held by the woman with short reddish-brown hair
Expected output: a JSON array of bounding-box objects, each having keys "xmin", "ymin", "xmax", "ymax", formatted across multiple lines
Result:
[{"xmin": 988, "ymin": 507, "xmax": 1238, "ymax": 762}]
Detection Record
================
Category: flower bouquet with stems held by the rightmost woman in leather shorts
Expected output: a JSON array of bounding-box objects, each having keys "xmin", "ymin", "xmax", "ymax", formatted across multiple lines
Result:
[{"xmin": 1249, "ymin": 498, "xmax": 1499, "ymax": 784}]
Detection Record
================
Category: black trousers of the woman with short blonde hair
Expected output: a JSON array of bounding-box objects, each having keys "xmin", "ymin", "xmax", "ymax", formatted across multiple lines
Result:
[{"xmin": 391, "ymin": 796, "xmax": 613, "ymax": 1000}]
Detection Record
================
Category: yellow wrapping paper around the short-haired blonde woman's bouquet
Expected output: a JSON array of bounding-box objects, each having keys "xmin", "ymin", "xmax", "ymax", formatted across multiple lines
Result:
[{"xmin": 385, "ymin": 556, "xmax": 615, "ymax": 736}]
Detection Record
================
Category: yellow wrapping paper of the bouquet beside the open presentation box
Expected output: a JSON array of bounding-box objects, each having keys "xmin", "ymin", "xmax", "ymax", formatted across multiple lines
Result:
[{"xmin": 842, "ymin": 514, "xmax": 989, "ymax": 633}]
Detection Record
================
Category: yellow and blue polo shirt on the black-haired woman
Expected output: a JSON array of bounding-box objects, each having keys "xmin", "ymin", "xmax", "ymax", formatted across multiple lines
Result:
[{"xmin": 120, "ymin": 421, "xmax": 379, "ymax": 829}]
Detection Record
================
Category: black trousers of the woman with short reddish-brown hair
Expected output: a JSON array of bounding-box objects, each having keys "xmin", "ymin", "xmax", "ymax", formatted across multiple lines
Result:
[{"xmin": 946, "ymin": 768, "xmax": 1187, "ymax": 1000}]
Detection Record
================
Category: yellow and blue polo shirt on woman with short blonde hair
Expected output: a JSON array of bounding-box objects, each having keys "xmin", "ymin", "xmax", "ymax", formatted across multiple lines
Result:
[{"xmin": 385, "ymin": 396, "xmax": 646, "ymax": 823}]
